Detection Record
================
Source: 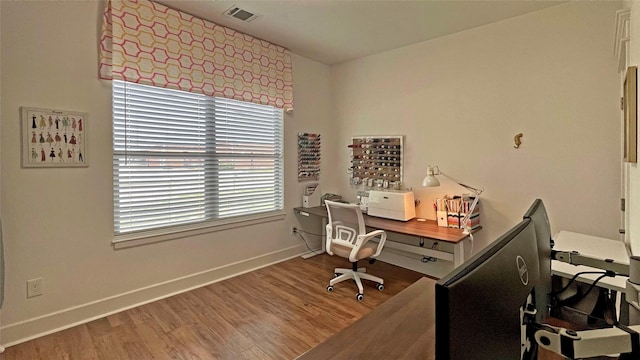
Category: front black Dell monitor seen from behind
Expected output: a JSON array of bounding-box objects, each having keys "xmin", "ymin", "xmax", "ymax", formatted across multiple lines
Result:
[{"xmin": 435, "ymin": 218, "xmax": 550, "ymax": 360}]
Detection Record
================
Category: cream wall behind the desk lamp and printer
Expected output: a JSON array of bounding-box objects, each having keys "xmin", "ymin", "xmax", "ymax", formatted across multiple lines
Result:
[{"xmin": 331, "ymin": 2, "xmax": 621, "ymax": 251}]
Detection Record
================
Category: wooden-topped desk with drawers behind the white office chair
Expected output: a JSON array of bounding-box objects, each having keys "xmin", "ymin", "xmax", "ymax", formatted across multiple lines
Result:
[{"xmin": 294, "ymin": 206, "xmax": 470, "ymax": 267}]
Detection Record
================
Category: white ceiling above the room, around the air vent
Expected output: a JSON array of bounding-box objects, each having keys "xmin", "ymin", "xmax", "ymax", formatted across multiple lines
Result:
[{"xmin": 155, "ymin": 0, "xmax": 563, "ymax": 65}]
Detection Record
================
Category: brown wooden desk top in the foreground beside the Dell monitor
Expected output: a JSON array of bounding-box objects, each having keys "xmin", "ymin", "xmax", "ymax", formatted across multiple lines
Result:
[{"xmin": 298, "ymin": 277, "xmax": 436, "ymax": 360}]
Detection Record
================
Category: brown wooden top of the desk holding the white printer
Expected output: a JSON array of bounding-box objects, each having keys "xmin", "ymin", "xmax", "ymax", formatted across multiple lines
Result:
[{"xmin": 294, "ymin": 206, "xmax": 468, "ymax": 243}]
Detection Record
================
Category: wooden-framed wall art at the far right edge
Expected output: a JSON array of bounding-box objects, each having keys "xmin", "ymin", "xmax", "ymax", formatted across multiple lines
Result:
[{"xmin": 622, "ymin": 66, "xmax": 638, "ymax": 163}]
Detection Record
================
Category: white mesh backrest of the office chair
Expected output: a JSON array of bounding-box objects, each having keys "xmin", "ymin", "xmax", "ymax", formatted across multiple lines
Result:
[{"xmin": 325, "ymin": 201, "xmax": 366, "ymax": 244}]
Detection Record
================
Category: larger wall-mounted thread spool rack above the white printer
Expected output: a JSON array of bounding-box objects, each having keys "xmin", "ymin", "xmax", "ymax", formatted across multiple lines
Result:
[{"xmin": 348, "ymin": 136, "xmax": 403, "ymax": 190}]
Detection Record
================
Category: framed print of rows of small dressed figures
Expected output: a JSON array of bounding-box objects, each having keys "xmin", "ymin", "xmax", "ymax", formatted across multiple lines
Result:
[{"xmin": 20, "ymin": 107, "xmax": 89, "ymax": 167}]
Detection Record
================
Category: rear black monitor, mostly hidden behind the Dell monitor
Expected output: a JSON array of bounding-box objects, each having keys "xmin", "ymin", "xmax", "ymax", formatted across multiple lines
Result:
[{"xmin": 523, "ymin": 199, "xmax": 553, "ymax": 324}]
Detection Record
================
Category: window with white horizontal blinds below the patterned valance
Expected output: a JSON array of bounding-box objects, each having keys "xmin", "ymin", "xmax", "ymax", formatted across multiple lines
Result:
[{"xmin": 113, "ymin": 81, "xmax": 284, "ymax": 235}]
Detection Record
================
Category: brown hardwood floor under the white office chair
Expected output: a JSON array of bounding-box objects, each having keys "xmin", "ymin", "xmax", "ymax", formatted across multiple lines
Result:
[{"xmin": 5, "ymin": 254, "xmax": 423, "ymax": 360}]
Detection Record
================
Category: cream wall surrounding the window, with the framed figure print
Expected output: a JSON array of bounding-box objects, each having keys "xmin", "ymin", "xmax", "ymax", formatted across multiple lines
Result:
[{"xmin": 0, "ymin": 1, "xmax": 333, "ymax": 344}]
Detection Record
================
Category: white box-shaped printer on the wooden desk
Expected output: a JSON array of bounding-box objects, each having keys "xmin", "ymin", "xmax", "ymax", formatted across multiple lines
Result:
[{"xmin": 367, "ymin": 190, "xmax": 416, "ymax": 221}]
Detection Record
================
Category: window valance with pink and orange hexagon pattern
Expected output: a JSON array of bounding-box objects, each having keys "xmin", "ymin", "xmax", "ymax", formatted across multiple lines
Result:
[{"xmin": 100, "ymin": 0, "xmax": 293, "ymax": 110}]
